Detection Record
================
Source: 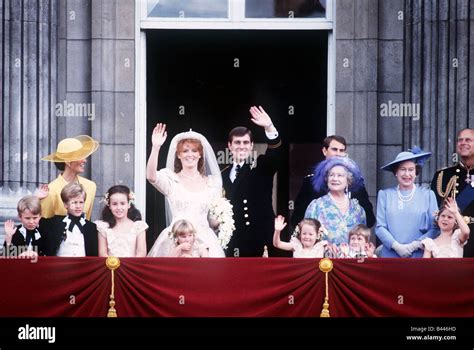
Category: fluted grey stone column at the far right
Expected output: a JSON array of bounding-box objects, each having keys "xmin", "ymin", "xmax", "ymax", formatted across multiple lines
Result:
[{"xmin": 403, "ymin": 0, "xmax": 474, "ymax": 182}]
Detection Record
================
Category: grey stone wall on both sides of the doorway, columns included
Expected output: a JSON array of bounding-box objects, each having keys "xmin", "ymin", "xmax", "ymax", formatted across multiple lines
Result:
[{"xmin": 0, "ymin": 0, "xmax": 474, "ymax": 239}]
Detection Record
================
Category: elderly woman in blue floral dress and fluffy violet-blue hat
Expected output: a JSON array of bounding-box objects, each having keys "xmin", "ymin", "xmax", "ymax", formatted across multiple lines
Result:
[{"xmin": 305, "ymin": 157, "xmax": 366, "ymax": 246}]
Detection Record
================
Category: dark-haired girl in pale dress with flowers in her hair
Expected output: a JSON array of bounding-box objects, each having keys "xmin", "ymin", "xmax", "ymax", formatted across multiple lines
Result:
[{"xmin": 95, "ymin": 185, "xmax": 148, "ymax": 257}]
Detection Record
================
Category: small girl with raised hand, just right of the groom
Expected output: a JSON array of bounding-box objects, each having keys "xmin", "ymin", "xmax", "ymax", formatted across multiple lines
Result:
[{"xmin": 273, "ymin": 215, "xmax": 328, "ymax": 258}]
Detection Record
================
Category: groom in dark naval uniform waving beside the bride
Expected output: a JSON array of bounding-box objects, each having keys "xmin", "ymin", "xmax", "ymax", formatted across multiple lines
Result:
[{"xmin": 222, "ymin": 106, "xmax": 282, "ymax": 257}]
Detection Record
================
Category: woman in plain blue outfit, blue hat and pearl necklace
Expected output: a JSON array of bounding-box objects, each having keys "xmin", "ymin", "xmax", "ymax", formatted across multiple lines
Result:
[{"xmin": 375, "ymin": 148, "xmax": 438, "ymax": 258}]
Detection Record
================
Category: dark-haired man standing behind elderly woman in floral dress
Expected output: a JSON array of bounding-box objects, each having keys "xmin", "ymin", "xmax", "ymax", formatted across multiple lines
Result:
[{"xmin": 291, "ymin": 135, "xmax": 375, "ymax": 227}]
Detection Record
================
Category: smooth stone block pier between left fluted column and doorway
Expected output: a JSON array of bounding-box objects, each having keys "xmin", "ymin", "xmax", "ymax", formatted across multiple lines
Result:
[{"xmin": 58, "ymin": 0, "xmax": 135, "ymax": 219}]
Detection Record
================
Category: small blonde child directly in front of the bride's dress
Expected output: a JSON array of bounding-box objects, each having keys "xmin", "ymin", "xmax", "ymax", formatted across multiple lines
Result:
[{"xmin": 169, "ymin": 220, "xmax": 209, "ymax": 258}]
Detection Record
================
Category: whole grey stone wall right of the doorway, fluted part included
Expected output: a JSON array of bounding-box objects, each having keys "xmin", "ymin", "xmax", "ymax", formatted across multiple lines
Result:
[{"xmin": 335, "ymin": 0, "xmax": 474, "ymax": 204}]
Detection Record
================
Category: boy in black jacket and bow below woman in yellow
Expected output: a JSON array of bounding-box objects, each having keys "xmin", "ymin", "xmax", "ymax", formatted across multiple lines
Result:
[{"xmin": 40, "ymin": 183, "xmax": 99, "ymax": 257}]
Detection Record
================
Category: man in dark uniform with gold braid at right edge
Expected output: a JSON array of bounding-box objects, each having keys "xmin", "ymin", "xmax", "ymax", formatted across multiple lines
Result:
[{"xmin": 431, "ymin": 128, "xmax": 474, "ymax": 258}]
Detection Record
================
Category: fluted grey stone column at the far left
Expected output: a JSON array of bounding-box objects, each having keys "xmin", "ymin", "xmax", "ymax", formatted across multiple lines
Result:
[{"xmin": 0, "ymin": 0, "xmax": 58, "ymax": 221}]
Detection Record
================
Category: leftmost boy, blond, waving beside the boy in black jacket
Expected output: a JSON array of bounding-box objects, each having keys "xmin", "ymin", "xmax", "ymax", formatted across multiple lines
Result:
[{"xmin": 3, "ymin": 196, "xmax": 44, "ymax": 257}]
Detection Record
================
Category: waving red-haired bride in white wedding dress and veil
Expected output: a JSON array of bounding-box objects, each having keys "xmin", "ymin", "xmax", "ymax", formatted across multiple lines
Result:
[{"xmin": 146, "ymin": 123, "xmax": 225, "ymax": 257}]
